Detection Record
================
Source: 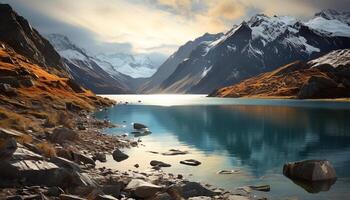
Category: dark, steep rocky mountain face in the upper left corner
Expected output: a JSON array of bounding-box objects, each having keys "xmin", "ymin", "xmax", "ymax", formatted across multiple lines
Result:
[{"xmin": 0, "ymin": 4, "xmax": 68, "ymax": 76}]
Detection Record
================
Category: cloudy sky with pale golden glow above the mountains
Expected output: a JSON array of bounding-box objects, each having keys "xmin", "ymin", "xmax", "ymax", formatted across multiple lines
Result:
[{"xmin": 0, "ymin": 0, "xmax": 349, "ymax": 61}]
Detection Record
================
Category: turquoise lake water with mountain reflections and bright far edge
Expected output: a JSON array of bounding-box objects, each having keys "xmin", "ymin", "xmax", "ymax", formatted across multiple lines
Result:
[{"xmin": 96, "ymin": 95, "xmax": 350, "ymax": 200}]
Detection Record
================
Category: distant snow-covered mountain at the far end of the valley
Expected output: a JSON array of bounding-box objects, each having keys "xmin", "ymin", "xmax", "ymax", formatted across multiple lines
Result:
[{"xmin": 96, "ymin": 53, "xmax": 157, "ymax": 78}]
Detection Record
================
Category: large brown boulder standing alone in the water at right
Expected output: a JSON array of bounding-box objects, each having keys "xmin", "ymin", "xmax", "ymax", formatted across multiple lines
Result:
[{"xmin": 283, "ymin": 160, "xmax": 337, "ymax": 181}]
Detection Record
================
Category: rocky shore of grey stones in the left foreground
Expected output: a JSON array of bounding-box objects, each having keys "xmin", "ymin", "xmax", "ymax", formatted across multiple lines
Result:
[{"xmin": 0, "ymin": 108, "xmax": 266, "ymax": 200}]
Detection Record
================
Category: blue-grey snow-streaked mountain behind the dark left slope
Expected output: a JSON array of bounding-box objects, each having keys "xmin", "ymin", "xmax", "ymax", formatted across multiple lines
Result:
[{"xmin": 47, "ymin": 34, "xmax": 130, "ymax": 94}]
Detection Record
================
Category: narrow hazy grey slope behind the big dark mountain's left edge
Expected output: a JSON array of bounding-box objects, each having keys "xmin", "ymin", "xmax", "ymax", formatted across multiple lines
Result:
[{"xmin": 139, "ymin": 33, "xmax": 223, "ymax": 93}]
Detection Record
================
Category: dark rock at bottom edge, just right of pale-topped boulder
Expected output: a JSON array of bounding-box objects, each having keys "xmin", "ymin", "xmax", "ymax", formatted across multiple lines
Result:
[{"xmin": 181, "ymin": 182, "xmax": 217, "ymax": 199}]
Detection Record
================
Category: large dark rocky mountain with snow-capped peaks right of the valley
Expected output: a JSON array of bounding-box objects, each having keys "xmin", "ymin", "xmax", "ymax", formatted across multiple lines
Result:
[{"xmin": 159, "ymin": 10, "xmax": 350, "ymax": 93}]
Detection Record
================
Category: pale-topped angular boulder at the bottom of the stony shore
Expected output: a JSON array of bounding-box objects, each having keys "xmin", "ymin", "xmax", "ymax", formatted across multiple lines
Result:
[{"xmin": 125, "ymin": 179, "xmax": 163, "ymax": 198}]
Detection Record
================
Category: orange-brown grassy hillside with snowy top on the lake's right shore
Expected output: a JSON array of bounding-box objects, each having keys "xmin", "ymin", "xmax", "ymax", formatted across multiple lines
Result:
[{"xmin": 210, "ymin": 49, "xmax": 350, "ymax": 99}]
